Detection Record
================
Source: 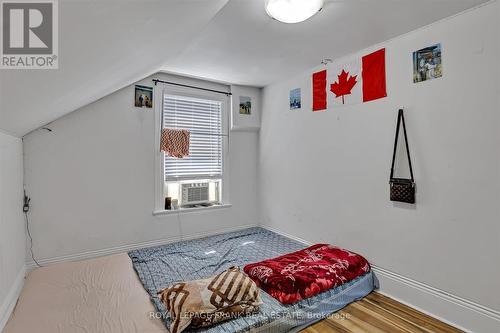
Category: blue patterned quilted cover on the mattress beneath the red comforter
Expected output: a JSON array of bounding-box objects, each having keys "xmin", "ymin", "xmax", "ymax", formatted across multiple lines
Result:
[{"xmin": 129, "ymin": 228, "xmax": 375, "ymax": 333}]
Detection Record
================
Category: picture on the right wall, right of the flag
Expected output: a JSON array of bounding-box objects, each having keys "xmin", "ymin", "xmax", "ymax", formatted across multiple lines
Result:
[{"xmin": 413, "ymin": 44, "xmax": 443, "ymax": 83}]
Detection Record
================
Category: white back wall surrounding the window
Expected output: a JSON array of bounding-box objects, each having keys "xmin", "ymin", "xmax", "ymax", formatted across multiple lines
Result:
[{"xmin": 24, "ymin": 74, "xmax": 258, "ymax": 259}]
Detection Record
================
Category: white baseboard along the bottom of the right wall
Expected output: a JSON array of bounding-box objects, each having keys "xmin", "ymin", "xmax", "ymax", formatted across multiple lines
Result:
[{"xmin": 261, "ymin": 226, "xmax": 500, "ymax": 333}]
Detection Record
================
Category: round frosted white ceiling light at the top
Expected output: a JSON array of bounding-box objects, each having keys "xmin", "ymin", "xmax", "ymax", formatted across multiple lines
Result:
[{"xmin": 266, "ymin": 0, "xmax": 325, "ymax": 23}]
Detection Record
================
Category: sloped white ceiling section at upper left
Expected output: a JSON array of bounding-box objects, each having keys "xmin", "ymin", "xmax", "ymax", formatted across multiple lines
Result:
[{"xmin": 0, "ymin": 0, "xmax": 228, "ymax": 136}]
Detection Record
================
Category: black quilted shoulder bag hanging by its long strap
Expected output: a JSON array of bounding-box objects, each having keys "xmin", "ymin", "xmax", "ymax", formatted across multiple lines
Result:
[{"xmin": 389, "ymin": 109, "xmax": 415, "ymax": 204}]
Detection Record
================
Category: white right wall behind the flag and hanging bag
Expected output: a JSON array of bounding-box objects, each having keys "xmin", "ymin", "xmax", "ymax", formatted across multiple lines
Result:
[{"xmin": 259, "ymin": 2, "xmax": 500, "ymax": 325}]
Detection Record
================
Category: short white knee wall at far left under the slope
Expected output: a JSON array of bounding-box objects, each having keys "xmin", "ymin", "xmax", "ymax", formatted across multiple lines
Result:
[{"xmin": 0, "ymin": 132, "xmax": 26, "ymax": 331}]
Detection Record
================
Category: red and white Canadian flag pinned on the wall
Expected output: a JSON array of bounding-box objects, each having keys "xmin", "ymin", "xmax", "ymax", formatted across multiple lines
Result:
[{"xmin": 312, "ymin": 49, "xmax": 387, "ymax": 111}]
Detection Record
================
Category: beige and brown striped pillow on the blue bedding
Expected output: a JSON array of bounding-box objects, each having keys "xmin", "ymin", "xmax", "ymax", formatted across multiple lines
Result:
[{"xmin": 158, "ymin": 267, "xmax": 262, "ymax": 333}]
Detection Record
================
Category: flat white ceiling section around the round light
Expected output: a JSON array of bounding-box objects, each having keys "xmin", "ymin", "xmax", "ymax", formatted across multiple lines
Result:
[{"xmin": 163, "ymin": 0, "xmax": 486, "ymax": 86}]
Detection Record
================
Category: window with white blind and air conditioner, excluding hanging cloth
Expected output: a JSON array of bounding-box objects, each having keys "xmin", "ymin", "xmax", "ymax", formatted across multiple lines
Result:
[{"xmin": 162, "ymin": 92, "xmax": 226, "ymax": 207}]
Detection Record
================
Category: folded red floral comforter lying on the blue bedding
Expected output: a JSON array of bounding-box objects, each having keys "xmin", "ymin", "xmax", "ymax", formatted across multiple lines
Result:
[{"xmin": 244, "ymin": 244, "xmax": 370, "ymax": 304}]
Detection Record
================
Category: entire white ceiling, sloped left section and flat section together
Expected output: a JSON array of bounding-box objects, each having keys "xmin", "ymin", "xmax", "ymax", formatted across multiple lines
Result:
[{"xmin": 0, "ymin": 0, "xmax": 487, "ymax": 136}]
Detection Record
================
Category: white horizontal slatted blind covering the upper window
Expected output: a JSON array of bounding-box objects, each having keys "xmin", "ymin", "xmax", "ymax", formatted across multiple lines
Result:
[{"xmin": 163, "ymin": 95, "xmax": 222, "ymax": 180}]
